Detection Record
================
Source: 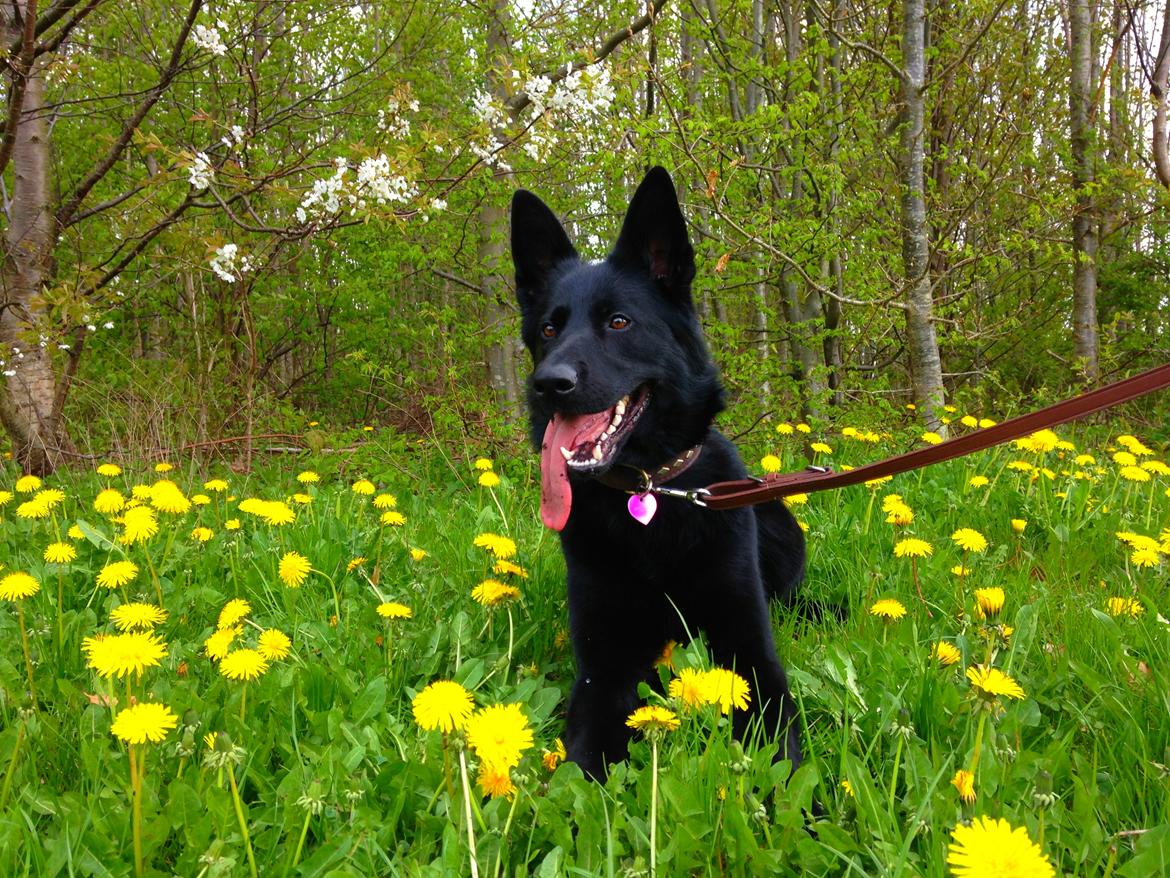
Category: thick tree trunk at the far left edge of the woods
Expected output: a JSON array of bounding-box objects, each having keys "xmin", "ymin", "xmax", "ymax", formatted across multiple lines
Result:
[{"xmin": 0, "ymin": 0, "xmax": 68, "ymax": 475}]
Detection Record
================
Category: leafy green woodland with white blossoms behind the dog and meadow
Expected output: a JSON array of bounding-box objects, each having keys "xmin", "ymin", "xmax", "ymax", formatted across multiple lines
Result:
[{"xmin": 0, "ymin": 0, "xmax": 1170, "ymax": 473}]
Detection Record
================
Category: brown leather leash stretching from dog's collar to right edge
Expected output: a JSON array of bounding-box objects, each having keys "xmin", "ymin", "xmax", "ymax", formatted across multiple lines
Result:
[{"xmin": 683, "ymin": 363, "xmax": 1170, "ymax": 509}]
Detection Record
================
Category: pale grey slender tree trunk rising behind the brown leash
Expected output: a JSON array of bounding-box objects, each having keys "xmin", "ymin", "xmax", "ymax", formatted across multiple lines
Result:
[{"xmin": 901, "ymin": 0, "xmax": 945, "ymax": 431}]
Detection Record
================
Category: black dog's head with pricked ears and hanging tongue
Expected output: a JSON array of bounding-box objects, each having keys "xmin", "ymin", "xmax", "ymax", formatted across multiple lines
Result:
[{"xmin": 511, "ymin": 167, "xmax": 723, "ymax": 530}]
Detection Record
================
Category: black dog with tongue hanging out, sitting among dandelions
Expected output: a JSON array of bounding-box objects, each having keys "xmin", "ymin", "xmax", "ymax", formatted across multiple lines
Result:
[{"xmin": 511, "ymin": 167, "xmax": 805, "ymax": 776}]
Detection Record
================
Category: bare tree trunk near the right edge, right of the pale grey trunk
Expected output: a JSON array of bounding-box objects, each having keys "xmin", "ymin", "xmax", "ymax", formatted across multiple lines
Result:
[{"xmin": 1068, "ymin": 0, "xmax": 1100, "ymax": 382}]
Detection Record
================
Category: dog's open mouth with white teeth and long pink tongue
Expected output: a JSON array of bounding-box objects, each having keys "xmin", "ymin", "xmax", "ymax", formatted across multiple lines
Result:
[{"xmin": 541, "ymin": 387, "xmax": 649, "ymax": 530}]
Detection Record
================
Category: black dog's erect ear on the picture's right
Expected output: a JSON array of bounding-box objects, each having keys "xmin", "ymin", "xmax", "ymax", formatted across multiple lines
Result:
[{"xmin": 610, "ymin": 167, "xmax": 695, "ymax": 296}]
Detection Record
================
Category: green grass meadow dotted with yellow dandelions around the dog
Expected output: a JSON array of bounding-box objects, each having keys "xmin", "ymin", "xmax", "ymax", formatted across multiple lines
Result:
[{"xmin": 0, "ymin": 428, "xmax": 1170, "ymax": 876}]
